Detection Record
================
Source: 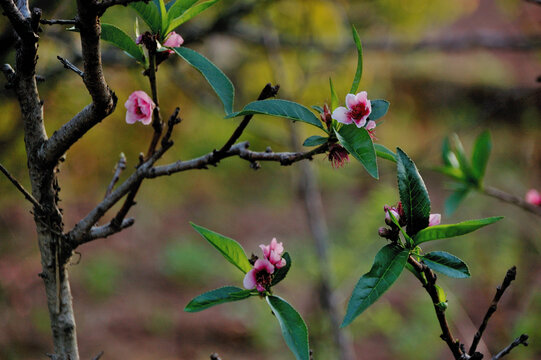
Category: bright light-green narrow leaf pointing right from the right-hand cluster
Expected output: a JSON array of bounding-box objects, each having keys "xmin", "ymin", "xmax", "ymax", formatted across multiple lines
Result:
[{"xmin": 413, "ymin": 216, "xmax": 503, "ymax": 245}]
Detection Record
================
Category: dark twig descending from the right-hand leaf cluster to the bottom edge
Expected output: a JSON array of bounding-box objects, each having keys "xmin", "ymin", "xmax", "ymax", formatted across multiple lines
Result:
[{"xmin": 408, "ymin": 256, "xmax": 463, "ymax": 360}]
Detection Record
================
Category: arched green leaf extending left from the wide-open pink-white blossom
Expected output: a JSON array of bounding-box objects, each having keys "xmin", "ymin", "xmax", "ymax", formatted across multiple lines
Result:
[{"xmin": 226, "ymin": 99, "xmax": 325, "ymax": 130}]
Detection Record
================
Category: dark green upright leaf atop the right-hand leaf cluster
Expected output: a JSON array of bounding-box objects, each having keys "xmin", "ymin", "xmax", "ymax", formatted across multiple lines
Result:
[{"xmin": 396, "ymin": 148, "xmax": 430, "ymax": 236}]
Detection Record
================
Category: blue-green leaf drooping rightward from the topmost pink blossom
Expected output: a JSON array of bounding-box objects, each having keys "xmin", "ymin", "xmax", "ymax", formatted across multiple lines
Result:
[{"xmin": 173, "ymin": 47, "xmax": 235, "ymax": 114}]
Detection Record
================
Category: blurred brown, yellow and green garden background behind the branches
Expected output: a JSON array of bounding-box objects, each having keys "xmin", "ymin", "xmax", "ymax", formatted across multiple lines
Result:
[{"xmin": 0, "ymin": 0, "xmax": 541, "ymax": 360}]
